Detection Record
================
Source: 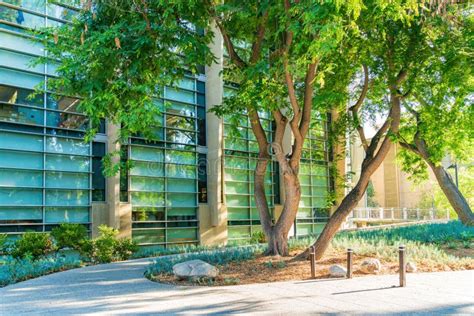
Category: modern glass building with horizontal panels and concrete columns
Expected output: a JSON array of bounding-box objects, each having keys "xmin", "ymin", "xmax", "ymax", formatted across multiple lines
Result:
[{"xmin": 0, "ymin": 0, "xmax": 330, "ymax": 247}]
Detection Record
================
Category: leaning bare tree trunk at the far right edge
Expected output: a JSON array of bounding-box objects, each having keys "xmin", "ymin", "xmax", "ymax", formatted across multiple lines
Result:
[{"xmin": 412, "ymin": 138, "xmax": 474, "ymax": 226}]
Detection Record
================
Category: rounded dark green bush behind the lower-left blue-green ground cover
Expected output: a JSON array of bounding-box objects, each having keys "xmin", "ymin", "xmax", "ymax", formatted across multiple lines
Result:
[{"xmin": 11, "ymin": 232, "xmax": 55, "ymax": 260}]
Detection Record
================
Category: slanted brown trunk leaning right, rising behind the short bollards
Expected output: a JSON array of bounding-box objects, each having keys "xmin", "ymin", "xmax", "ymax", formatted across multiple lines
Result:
[{"xmin": 303, "ymin": 91, "xmax": 400, "ymax": 260}]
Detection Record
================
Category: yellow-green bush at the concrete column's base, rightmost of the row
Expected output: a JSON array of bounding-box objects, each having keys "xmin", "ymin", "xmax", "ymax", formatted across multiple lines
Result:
[{"xmin": 86, "ymin": 225, "xmax": 138, "ymax": 263}]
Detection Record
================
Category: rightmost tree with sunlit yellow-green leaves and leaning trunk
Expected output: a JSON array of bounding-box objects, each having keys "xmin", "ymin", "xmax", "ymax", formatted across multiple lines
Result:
[{"xmin": 398, "ymin": 7, "xmax": 474, "ymax": 225}]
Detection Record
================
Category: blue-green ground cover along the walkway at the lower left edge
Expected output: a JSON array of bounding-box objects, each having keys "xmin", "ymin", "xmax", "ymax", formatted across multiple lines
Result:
[{"xmin": 0, "ymin": 254, "xmax": 82, "ymax": 286}]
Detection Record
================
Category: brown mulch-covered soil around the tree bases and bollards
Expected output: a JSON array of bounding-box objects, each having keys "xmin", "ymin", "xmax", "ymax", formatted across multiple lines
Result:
[{"xmin": 148, "ymin": 248, "xmax": 474, "ymax": 286}]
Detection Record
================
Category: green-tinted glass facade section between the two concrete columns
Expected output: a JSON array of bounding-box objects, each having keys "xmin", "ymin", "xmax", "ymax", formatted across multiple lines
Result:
[{"xmin": 128, "ymin": 77, "xmax": 206, "ymax": 247}]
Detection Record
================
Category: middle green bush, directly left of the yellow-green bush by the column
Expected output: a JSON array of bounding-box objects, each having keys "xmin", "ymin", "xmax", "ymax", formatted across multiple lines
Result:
[{"xmin": 51, "ymin": 223, "xmax": 88, "ymax": 253}]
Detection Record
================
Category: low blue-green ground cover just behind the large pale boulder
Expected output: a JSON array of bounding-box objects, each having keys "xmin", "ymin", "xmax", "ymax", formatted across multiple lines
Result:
[{"xmin": 145, "ymin": 246, "xmax": 263, "ymax": 278}]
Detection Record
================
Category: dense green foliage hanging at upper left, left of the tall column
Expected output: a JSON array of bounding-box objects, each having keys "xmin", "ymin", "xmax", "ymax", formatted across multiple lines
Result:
[{"xmin": 36, "ymin": 0, "xmax": 213, "ymax": 145}]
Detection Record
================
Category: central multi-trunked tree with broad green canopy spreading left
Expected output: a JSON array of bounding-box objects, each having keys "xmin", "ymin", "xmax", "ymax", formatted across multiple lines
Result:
[{"xmin": 38, "ymin": 0, "xmax": 361, "ymax": 255}]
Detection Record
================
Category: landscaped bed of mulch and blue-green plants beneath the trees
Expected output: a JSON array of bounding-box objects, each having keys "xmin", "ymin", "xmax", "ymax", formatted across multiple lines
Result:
[{"xmin": 146, "ymin": 222, "xmax": 474, "ymax": 285}]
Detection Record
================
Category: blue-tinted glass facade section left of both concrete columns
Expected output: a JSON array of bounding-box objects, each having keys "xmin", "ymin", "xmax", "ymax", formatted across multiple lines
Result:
[{"xmin": 0, "ymin": 0, "xmax": 92, "ymax": 233}]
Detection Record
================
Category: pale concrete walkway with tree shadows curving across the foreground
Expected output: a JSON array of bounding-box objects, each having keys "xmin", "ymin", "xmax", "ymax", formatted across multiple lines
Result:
[{"xmin": 0, "ymin": 259, "xmax": 474, "ymax": 316}]
